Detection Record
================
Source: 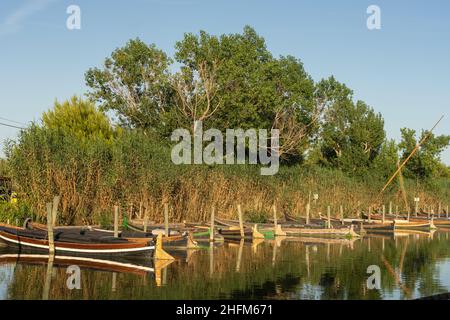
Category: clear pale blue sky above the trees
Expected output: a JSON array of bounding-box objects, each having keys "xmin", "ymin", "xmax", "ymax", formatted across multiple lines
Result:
[{"xmin": 0, "ymin": 0, "xmax": 450, "ymax": 165}]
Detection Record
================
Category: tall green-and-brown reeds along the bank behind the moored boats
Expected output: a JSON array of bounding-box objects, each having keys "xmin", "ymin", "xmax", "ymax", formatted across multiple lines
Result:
[{"xmin": 4, "ymin": 126, "xmax": 450, "ymax": 224}]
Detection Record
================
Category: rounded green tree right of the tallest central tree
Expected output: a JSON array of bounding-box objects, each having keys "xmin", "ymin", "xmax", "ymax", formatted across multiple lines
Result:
[{"xmin": 317, "ymin": 77, "xmax": 385, "ymax": 173}]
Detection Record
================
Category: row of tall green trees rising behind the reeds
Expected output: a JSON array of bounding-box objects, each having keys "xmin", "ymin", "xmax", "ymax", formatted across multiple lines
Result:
[{"xmin": 81, "ymin": 26, "xmax": 448, "ymax": 177}]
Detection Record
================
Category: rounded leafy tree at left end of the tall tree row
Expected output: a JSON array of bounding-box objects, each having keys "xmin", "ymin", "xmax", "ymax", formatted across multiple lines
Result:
[{"xmin": 85, "ymin": 39, "xmax": 174, "ymax": 129}]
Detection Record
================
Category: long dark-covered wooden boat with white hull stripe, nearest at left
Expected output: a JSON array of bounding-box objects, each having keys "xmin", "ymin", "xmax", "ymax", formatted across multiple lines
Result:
[{"xmin": 0, "ymin": 225, "xmax": 155, "ymax": 255}]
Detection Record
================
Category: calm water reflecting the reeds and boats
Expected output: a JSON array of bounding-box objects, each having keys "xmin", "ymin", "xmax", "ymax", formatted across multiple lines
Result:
[{"xmin": 0, "ymin": 232, "xmax": 450, "ymax": 299}]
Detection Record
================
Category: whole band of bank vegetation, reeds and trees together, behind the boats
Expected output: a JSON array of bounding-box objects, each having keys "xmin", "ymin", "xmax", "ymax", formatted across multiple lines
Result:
[{"xmin": 0, "ymin": 27, "xmax": 450, "ymax": 224}]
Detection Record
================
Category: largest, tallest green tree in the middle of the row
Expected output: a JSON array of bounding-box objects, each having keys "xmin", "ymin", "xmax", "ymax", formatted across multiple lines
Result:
[{"xmin": 171, "ymin": 27, "xmax": 318, "ymax": 157}]
